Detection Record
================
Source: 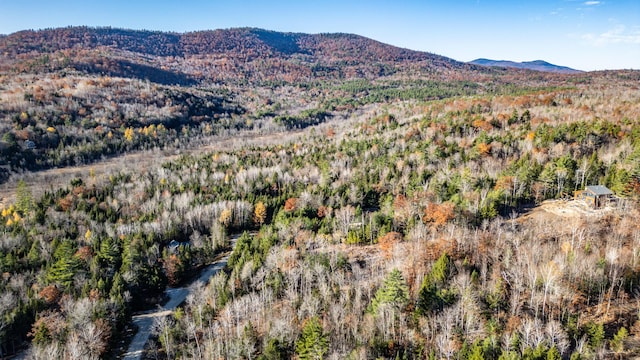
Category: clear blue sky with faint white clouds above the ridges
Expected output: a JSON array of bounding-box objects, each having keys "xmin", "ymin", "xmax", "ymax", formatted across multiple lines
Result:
[{"xmin": 0, "ymin": 0, "xmax": 640, "ymax": 70}]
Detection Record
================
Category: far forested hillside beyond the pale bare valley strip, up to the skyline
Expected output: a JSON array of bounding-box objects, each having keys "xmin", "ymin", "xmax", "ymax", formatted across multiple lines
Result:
[{"xmin": 0, "ymin": 27, "xmax": 580, "ymax": 181}]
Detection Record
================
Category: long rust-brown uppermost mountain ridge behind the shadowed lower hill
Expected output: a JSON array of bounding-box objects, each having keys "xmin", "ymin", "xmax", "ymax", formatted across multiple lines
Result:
[{"xmin": 0, "ymin": 26, "xmax": 464, "ymax": 65}]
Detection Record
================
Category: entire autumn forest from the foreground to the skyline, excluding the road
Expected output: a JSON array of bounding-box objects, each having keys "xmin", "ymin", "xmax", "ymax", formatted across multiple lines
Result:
[{"xmin": 0, "ymin": 28, "xmax": 640, "ymax": 359}]
